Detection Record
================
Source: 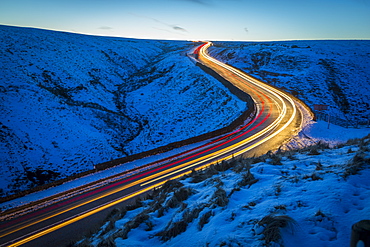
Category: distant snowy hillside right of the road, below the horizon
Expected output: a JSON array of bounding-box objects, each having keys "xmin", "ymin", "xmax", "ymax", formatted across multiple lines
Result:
[{"xmin": 210, "ymin": 41, "xmax": 370, "ymax": 124}]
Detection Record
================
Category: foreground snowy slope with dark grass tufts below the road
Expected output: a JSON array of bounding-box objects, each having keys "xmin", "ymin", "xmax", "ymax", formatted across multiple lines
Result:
[{"xmin": 76, "ymin": 135, "xmax": 370, "ymax": 247}]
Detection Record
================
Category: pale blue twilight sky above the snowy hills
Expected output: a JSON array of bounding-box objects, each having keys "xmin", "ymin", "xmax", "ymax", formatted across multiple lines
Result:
[{"xmin": 0, "ymin": 0, "xmax": 370, "ymax": 41}]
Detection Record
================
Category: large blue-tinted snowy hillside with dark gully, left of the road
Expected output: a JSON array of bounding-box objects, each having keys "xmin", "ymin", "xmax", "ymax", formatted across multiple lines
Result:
[{"xmin": 0, "ymin": 26, "xmax": 246, "ymax": 196}]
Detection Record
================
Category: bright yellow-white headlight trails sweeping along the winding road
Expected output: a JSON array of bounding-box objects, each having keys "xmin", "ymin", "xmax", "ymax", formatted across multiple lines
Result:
[{"xmin": 0, "ymin": 42, "xmax": 297, "ymax": 246}]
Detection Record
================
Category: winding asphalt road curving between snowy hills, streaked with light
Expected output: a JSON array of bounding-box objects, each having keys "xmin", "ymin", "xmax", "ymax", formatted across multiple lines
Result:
[{"xmin": 0, "ymin": 42, "xmax": 301, "ymax": 246}]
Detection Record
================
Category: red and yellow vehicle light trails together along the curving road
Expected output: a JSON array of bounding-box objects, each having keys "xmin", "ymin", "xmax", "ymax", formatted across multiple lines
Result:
[{"xmin": 0, "ymin": 42, "xmax": 297, "ymax": 246}]
